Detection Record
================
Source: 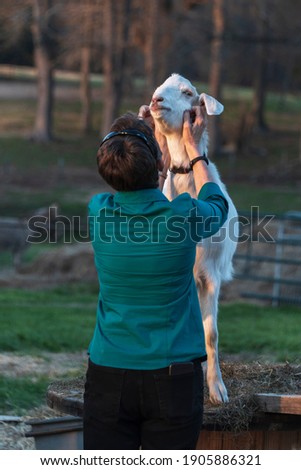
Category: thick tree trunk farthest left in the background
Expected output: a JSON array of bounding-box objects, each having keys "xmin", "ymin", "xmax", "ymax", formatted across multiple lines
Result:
[{"xmin": 32, "ymin": 0, "xmax": 54, "ymax": 142}]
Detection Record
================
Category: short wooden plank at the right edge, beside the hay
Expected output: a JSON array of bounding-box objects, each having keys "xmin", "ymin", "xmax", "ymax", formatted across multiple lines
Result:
[{"xmin": 255, "ymin": 393, "xmax": 301, "ymax": 416}]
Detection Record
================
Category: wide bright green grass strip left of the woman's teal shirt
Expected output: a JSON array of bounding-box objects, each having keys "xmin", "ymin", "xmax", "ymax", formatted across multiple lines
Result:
[{"xmin": 0, "ymin": 284, "xmax": 97, "ymax": 353}]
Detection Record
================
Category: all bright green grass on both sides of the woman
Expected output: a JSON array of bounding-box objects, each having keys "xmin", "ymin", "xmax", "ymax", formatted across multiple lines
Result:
[{"xmin": 0, "ymin": 283, "xmax": 301, "ymax": 414}]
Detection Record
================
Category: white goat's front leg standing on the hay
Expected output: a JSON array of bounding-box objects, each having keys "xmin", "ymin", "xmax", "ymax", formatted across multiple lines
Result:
[{"xmin": 198, "ymin": 279, "xmax": 228, "ymax": 404}]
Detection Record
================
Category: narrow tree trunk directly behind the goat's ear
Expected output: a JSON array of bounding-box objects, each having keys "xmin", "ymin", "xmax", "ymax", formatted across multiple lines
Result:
[{"xmin": 209, "ymin": 0, "xmax": 225, "ymax": 156}]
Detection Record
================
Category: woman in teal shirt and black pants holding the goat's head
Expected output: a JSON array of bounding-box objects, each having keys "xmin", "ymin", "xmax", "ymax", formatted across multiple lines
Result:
[{"xmin": 84, "ymin": 107, "xmax": 228, "ymax": 449}]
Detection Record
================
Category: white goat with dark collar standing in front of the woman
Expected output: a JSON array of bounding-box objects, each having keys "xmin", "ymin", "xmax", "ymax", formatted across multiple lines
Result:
[{"xmin": 150, "ymin": 74, "xmax": 237, "ymax": 403}]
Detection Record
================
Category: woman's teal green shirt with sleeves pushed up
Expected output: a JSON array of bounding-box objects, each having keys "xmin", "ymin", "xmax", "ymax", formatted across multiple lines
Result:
[{"xmin": 89, "ymin": 183, "xmax": 228, "ymax": 370}]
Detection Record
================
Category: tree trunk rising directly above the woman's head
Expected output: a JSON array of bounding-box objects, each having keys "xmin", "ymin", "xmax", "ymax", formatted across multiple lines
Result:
[{"xmin": 102, "ymin": 0, "xmax": 131, "ymax": 134}]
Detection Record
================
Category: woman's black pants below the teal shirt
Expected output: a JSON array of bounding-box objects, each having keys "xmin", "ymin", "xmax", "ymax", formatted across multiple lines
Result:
[{"xmin": 84, "ymin": 360, "xmax": 203, "ymax": 450}]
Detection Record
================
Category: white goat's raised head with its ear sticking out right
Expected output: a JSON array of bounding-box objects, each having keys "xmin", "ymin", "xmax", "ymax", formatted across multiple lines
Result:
[{"xmin": 150, "ymin": 74, "xmax": 224, "ymax": 134}]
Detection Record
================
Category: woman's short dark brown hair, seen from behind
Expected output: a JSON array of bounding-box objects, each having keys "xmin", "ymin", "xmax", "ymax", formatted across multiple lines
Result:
[{"xmin": 97, "ymin": 113, "xmax": 161, "ymax": 191}]
